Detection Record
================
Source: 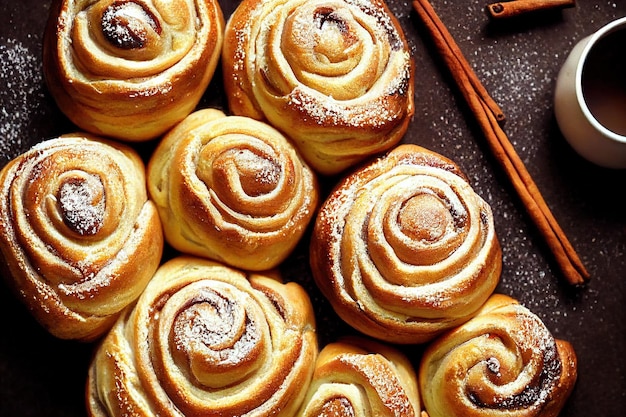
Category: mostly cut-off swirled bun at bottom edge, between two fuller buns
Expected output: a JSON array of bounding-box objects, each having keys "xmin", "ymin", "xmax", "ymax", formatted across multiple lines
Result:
[{"xmin": 296, "ymin": 337, "xmax": 420, "ymax": 417}]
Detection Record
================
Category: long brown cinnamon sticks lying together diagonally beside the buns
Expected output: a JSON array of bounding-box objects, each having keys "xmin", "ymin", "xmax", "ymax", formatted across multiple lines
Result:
[{"xmin": 413, "ymin": 0, "xmax": 589, "ymax": 285}]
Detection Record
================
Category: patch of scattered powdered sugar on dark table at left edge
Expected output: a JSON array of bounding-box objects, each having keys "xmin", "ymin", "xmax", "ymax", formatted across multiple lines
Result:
[{"xmin": 0, "ymin": 38, "xmax": 44, "ymax": 163}]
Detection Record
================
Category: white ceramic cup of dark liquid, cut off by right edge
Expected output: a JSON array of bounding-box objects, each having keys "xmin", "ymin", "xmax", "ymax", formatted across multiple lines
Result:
[{"xmin": 554, "ymin": 17, "xmax": 626, "ymax": 169}]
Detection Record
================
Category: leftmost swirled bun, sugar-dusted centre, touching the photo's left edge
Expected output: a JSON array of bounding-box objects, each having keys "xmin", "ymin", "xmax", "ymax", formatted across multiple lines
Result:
[{"xmin": 0, "ymin": 134, "xmax": 163, "ymax": 340}]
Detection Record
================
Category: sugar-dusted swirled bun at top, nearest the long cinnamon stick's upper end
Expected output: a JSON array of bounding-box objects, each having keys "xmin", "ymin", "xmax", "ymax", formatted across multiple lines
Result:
[{"xmin": 222, "ymin": 0, "xmax": 414, "ymax": 174}]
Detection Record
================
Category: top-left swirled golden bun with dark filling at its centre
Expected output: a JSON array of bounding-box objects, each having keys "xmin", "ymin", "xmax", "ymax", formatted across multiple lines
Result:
[{"xmin": 44, "ymin": 0, "xmax": 224, "ymax": 141}]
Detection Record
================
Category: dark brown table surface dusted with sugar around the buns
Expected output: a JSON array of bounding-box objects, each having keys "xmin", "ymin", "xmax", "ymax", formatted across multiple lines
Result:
[{"xmin": 0, "ymin": 0, "xmax": 626, "ymax": 417}]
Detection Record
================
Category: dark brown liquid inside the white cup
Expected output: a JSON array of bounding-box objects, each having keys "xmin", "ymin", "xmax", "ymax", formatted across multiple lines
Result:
[{"xmin": 581, "ymin": 29, "xmax": 626, "ymax": 136}]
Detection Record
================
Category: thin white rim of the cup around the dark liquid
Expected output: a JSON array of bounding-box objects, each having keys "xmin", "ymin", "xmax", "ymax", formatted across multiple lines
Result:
[{"xmin": 575, "ymin": 16, "xmax": 626, "ymax": 144}]
